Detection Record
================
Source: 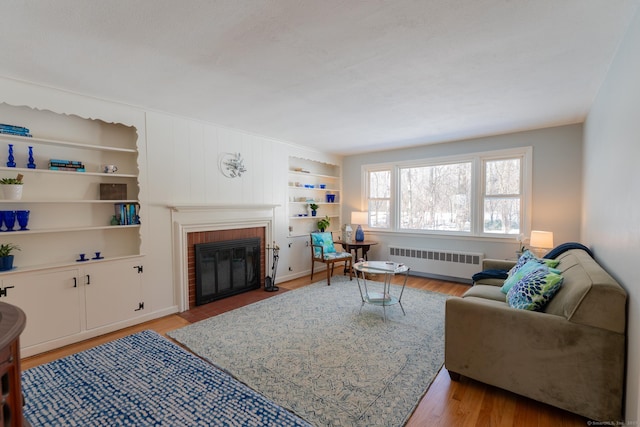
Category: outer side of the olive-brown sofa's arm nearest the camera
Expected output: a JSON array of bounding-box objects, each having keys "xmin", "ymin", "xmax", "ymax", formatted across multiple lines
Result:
[{"xmin": 445, "ymin": 297, "xmax": 625, "ymax": 420}]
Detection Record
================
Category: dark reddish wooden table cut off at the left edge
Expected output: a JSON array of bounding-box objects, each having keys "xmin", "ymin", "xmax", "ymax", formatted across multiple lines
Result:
[{"xmin": 0, "ymin": 302, "xmax": 30, "ymax": 427}]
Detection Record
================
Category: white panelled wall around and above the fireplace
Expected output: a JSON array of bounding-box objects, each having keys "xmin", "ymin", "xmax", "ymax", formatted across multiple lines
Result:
[{"xmin": 142, "ymin": 112, "xmax": 341, "ymax": 306}]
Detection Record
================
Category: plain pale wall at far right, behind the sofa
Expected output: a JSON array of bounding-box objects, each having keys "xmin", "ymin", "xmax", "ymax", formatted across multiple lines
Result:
[{"xmin": 582, "ymin": 8, "xmax": 640, "ymax": 422}]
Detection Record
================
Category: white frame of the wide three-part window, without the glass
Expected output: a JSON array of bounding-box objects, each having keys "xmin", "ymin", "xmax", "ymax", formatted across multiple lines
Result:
[{"xmin": 361, "ymin": 146, "xmax": 533, "ymax": 239}]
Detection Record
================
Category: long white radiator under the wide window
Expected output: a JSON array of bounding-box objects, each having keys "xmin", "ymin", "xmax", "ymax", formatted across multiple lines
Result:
[{"xmin": 389, "ymin": 246, "xmax": 484, "ymax": 280}]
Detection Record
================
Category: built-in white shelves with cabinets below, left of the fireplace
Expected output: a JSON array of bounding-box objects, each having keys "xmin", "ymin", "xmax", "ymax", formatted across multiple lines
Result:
[{"xmin": 0, "ymin": 103, "xmax": 148, "ymax": 356}]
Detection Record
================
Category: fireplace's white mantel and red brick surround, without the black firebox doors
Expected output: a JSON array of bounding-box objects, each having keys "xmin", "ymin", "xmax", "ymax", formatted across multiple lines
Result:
[{"xmin": 171, "ymin": 205, "xmax": 277, "ymax": 311}]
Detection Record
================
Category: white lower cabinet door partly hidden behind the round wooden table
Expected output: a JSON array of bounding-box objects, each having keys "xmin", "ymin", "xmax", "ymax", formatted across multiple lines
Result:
[{"xmin": 0, "ymin": 268, "xmax": 81, "ymax": 348}]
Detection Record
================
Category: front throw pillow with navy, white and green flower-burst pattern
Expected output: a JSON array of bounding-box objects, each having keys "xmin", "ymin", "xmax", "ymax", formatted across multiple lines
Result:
[{"xmin": 507, "ymin": 268, "xmax": 564, "ymax": 311}]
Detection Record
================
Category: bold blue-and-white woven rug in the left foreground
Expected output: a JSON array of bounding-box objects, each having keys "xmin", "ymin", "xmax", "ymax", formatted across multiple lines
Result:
[{"xmin": 22, "ymin": 331, "xmax": 309, "ymax": 427}]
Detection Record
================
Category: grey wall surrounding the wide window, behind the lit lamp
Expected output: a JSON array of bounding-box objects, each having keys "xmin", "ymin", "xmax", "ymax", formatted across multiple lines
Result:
[{"xmin": 342, "ymin": 125, "xmax": 582, "ymax": 259}]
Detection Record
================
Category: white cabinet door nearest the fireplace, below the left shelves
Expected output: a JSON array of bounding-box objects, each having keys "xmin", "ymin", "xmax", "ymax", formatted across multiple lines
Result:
[{"xmin": 81, "ymin": 259, "xmax": 145, "ymax": 329}]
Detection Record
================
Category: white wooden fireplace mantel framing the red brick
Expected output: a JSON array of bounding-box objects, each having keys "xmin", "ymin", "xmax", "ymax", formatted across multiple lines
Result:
[{"xmin": 169, "ymin": 204, "xmax": 279, "ymax": 311}]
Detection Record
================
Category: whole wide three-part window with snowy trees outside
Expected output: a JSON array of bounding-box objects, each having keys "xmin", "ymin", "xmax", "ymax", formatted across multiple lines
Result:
[{"xmin": 363, "ymin": 147, "xmax": 532, "ymax": 236}]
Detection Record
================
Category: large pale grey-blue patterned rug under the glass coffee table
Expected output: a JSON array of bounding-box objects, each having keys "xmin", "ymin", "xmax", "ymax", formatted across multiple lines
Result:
[{"xmin": 168, "ymin": 276, "xmax": 448, "ymax": 427}]
